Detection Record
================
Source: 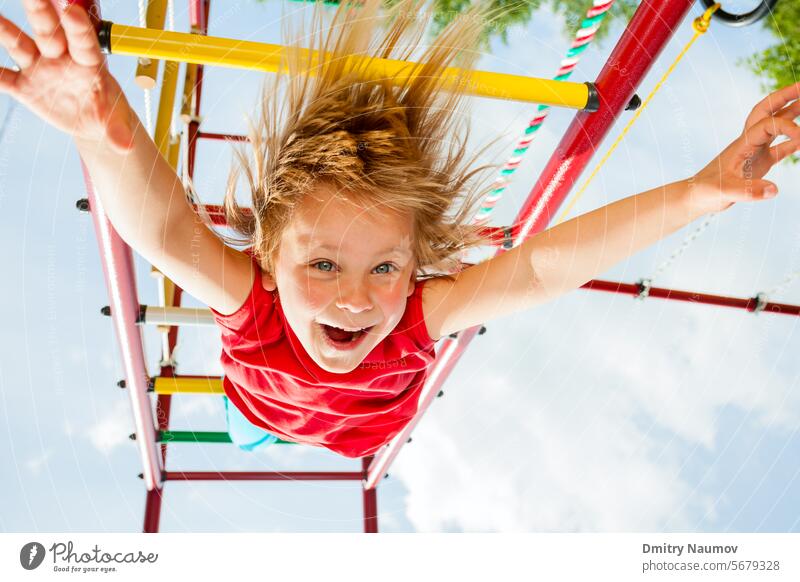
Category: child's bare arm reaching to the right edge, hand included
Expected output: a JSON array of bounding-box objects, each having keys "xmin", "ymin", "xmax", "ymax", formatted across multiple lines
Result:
[{"xmin": 423, "ymin": 83, "xmax": 800, "ymax": 338}]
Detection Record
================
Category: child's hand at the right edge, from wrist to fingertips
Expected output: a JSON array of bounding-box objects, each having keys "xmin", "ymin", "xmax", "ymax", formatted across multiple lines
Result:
[{"xmin": 687, "ymin": 83, "xmax": 800, "ymax": 214}]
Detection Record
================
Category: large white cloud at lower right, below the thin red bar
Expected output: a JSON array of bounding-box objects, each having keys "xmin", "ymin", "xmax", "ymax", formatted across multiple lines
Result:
[{"xmin": 390, "ymin": 280, "xmax": 800, "ymax": 531}]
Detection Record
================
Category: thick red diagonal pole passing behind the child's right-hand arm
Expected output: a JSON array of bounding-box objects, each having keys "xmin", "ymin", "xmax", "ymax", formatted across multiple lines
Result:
[{"xmin": 364, "ymin": 0, "xmax": 693, "ymax": 488}]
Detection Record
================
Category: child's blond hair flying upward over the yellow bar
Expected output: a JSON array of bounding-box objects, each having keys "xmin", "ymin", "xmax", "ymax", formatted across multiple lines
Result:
[{"xmin": 198, "ymin": 0, "xmax": 512, "ymax": 275}]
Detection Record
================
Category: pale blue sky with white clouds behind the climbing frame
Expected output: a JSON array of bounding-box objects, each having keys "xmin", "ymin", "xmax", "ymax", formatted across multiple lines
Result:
[{"xmin": 0, "ymin": 0, "xmax": 800, "ymax": 532}]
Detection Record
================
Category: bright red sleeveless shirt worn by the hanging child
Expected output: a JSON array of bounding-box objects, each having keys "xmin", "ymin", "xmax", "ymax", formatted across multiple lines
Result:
[{"xmin": 211, "ymin": 253, "xmax": 435, "ymax": 457}]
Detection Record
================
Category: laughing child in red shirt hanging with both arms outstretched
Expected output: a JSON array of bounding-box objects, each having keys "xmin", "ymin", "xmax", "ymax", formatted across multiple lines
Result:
[{"xmin": 0, "ymin": 0, "xmax": 800, "ymax": 457}]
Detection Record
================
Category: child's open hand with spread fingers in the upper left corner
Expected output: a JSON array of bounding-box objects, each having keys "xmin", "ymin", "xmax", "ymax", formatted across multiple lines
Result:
[{"xmin": 0, "ymin": 0, "xmax": 133, "ymax": 153}]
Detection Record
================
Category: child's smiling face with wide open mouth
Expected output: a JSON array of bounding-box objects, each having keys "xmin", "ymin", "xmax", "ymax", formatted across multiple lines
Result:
[{"xmin": 265, "ymin": 185, "xmax": 415, "ymax": 373}]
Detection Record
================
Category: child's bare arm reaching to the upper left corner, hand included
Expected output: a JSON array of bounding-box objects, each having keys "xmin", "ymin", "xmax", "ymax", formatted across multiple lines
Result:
[{"xmin": 0, "ymin": 0, "xmax": 253, "ymax": 313}]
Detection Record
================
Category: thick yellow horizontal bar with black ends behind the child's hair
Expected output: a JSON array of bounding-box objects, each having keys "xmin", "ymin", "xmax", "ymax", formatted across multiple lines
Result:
[{"xmin": 101, "ymin": 21, "xmax": 594, "ymax": 109}]
